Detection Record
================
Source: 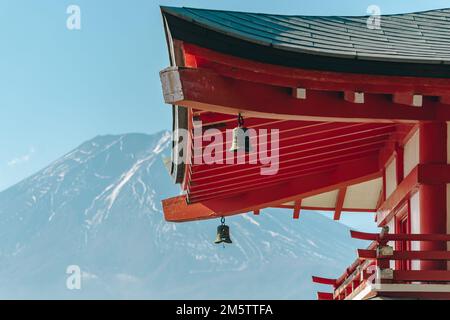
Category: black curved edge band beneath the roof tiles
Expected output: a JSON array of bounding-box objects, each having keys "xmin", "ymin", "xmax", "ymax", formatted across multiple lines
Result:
[{"xmin": 161, "ymin": 7, "xmax": 450, "ymax": 78}]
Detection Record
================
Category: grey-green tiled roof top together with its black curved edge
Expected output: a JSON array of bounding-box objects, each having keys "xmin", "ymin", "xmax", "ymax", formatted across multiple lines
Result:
[{"xmin": 161, "ymin": 7, "xmax": 450, "ymax": 77}]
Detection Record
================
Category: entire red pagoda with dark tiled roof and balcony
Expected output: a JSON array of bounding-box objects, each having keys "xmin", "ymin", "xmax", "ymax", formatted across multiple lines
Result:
[{"xmin": 157, "ymin": 7, "xmax": 450, "ymax": 300}]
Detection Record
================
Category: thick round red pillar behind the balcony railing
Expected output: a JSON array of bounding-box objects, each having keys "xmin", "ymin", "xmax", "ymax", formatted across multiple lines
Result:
[{"xmin": 419, "ymin": 122, "xmax": 447, "ymax": 270}]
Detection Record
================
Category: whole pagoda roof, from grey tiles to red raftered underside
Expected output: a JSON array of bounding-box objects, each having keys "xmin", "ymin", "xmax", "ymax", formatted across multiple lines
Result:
[{"xmin": 160, "ymin": 7, "xmax": 450, "ymax": 223}]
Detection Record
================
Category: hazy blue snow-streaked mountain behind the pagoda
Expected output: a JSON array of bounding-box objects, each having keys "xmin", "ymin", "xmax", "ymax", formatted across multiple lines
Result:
[{"xmin": 0, "ymin": 132, "xmax": 361, "ymax": 299}]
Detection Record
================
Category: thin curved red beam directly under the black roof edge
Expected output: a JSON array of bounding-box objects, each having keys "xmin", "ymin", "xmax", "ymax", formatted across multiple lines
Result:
[{"xmin": 184, "ymin": 43, "xmax": 450, "ymax": 96}]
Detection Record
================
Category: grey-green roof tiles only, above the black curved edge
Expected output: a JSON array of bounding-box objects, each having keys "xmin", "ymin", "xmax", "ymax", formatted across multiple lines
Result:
[{"xmin": 162, "ymin": 7, "xmax": 450, "ymax": 64}]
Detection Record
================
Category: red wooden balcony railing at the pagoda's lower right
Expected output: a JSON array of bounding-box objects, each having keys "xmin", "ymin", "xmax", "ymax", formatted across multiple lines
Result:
[{"xmin": 313, "ymin": 228, "xmax": 450, "ymax": 300}]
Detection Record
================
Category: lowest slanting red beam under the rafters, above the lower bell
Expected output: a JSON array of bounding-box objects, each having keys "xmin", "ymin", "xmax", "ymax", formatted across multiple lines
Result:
[{"xmin": 163, "ymin": 157, "xmax": 380, "ymax": 222}]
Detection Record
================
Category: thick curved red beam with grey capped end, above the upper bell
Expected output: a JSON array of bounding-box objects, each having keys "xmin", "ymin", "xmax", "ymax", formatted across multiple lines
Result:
[{"xmin": 161, "ymin": 67, "xmax": 440, "ymax": 122}]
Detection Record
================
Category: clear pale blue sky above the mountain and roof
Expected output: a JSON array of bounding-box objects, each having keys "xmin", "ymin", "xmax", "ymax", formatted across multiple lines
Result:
[{"xmin": 0, "ymin": 0, "xmax": 450, "ymax": 228}]
